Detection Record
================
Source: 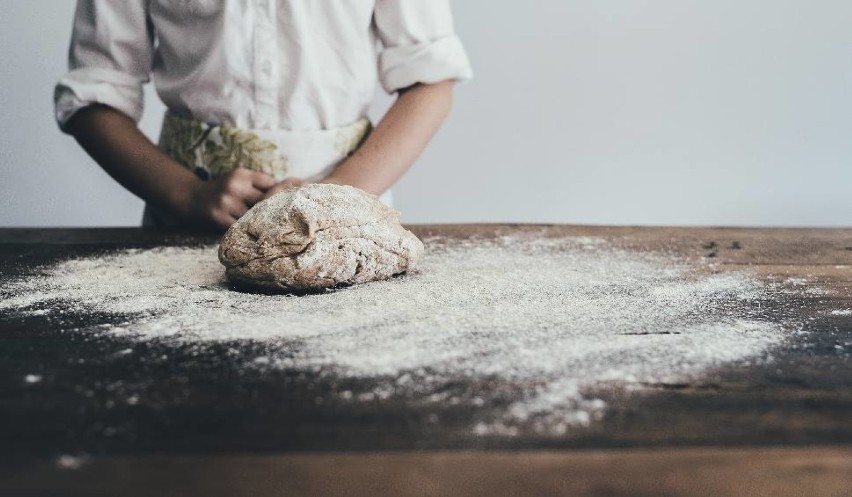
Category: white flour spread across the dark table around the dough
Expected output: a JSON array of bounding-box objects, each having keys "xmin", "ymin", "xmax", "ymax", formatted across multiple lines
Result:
[{"xmin": 0, "ymin": 235, "xmax": 785, "ymax": 435}]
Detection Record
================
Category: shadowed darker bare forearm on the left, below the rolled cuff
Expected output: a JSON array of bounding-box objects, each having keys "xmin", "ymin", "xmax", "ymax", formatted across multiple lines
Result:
[{"xmin": 68, "ymin": 105, "xmax": 200, "ymax": 211}]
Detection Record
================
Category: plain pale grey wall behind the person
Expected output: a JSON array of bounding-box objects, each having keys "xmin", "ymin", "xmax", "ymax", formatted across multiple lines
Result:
[{"xmin": 0, "ymin": 0, "xmax": 852, "ymax": 226}]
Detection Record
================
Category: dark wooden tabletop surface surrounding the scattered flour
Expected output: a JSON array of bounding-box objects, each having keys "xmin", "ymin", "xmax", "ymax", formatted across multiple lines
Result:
[{"xmin": 0, "ymin": 225, "xmax": 852, "ymax": 496}]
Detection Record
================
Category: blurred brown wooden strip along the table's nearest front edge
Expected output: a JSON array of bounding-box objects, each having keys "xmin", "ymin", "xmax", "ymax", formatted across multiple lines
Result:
[{"xmin": 0, "ymin": 447, "xmax": 852, "ymax": 497}]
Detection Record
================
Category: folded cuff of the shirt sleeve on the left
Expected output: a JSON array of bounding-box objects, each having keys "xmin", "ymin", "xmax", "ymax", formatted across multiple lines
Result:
[{"xmin": 53, "ymin": 68, "xmax": 144, "ymax": 133}]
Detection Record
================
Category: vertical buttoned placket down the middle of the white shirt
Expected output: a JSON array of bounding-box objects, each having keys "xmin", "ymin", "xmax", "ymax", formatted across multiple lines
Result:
[{"xmin": 253, "ymin": 0, "xmax": 279, "ymax": 129}]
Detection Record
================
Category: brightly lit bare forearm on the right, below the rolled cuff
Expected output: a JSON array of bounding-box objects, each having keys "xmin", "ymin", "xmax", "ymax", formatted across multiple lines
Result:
[{"xmin": 324, "ymin": 81, "xmax": 455, "ymax": 195}]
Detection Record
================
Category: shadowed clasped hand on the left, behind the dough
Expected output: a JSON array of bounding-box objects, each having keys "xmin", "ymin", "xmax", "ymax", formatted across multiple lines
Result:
[{"xmin": 179, "ymin": 168, "xmax": 276, "ymax": 231}]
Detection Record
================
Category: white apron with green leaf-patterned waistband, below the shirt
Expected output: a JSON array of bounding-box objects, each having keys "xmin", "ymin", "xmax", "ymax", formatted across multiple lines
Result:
[{"xmin": 142, "ymin": 112, "xmax": 392, "ymax": 226}]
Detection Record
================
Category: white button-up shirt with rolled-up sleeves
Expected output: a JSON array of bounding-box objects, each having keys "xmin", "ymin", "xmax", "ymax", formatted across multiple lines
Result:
[{"xmin": 55, "ymin": 0, "xmax": 471, "ymax": 131}]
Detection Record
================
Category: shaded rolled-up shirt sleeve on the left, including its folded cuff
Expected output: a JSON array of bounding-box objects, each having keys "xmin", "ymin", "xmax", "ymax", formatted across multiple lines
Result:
[{"xmin": 53, "ymin": 0, "xmax": 154, "ymax": 131}]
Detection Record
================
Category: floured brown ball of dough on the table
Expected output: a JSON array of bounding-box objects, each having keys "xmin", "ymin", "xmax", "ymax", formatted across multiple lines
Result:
[{"xmin": 219, "ymin": 184, "xmax": 423, "ymax": 292}]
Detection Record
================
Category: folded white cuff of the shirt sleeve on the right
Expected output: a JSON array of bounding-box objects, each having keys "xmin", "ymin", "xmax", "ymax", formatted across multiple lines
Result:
[{"xmin": 379, "ymin": 35, "xmax": 473, "ymax": 93}]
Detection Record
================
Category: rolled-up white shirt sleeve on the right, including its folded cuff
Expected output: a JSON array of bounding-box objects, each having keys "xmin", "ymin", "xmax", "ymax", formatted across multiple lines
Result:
[{"xmin": 374, "ymin": 0, "xmax": 472, "ymax": 93}]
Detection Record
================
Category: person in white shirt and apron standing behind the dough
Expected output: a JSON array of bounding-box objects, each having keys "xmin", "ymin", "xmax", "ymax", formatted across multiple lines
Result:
[{"xmin": 54, "ymin": 0, "xmax": 471, "ymax": 230}]
